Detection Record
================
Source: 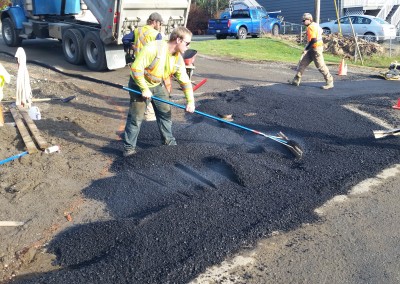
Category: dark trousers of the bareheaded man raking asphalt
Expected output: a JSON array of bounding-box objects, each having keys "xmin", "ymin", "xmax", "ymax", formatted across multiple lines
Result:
[{"xmin": 124, "ymin": 77, "xmax": 176, "ymax": 150}]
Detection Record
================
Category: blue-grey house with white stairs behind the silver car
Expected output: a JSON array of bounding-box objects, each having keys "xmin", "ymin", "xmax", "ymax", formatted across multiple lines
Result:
[{"xmin": 257, "ymin": 0, "xmax": 400, "ymax": 26}]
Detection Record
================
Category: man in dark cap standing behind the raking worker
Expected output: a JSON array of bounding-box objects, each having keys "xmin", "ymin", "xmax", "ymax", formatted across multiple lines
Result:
[{"xmin": 133, "ymin": 12, "xmax": 163, "ymax": 121}]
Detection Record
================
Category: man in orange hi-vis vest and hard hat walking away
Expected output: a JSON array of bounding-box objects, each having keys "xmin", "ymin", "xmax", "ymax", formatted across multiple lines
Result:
[{"xmin": 289, "ymin": 13, "xmax": 333, "ymax": 89}]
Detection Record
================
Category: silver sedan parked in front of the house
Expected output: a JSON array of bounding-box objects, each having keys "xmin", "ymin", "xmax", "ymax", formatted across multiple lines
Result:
[{"xmin": 320, "ymin": 15, "xmax": 396, "ymax": 41}]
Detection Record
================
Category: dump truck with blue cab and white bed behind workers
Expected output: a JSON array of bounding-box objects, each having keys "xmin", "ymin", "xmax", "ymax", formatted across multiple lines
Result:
[{"xmin": 1, "ymin": 0, "xmax": 191, "ymax": 71}]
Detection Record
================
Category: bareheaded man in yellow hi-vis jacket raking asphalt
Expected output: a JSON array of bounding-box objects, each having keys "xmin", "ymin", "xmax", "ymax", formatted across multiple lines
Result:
[{"xmin": 123, "ymin": 27, "xmax": 195, "ymax": 157}]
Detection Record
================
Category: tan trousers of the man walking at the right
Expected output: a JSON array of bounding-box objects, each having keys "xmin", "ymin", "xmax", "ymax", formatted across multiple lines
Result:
[{"xmin": 296, "ymin": 46, "xmax": 333, "ymax": 82}]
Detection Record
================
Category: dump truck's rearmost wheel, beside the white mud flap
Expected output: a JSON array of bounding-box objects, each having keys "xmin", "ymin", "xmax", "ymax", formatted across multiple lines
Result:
[{"xmin": 83, "ymin": 32, "xmax": 107, "ymax": 71}]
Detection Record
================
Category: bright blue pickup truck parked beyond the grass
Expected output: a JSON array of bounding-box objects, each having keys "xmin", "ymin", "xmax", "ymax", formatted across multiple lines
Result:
[{"xmin": 207, "ymin": 7, "xmax": 282, "ymax": 39}]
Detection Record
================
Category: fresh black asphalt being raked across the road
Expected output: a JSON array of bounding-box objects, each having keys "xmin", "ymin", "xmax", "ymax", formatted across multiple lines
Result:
[{"xmin": 15, "ymin": 81, "xmax": 400, "ymax": 283}]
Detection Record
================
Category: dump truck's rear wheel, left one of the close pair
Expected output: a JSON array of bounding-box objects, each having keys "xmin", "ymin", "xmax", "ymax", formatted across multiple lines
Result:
[{"xmin": 62, "ymin": 29, "xmax": 84, "ymax": 65}]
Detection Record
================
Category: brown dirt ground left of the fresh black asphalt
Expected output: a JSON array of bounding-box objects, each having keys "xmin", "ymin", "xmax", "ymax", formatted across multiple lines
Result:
[{"xmin": 0, "ymin": 53, "xmax": 136, "ymax": 282}]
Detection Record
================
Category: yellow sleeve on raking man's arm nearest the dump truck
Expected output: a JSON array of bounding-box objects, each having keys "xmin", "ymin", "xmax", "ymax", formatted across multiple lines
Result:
[{"xmin": 131, "ymin": 44, "xmax": 157, "ymax": 92}]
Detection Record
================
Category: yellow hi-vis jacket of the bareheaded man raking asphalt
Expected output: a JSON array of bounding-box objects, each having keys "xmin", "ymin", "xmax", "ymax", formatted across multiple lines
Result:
[{"xmin": 131, "ymin": 40, "xmax": 194, "ymax": 103}]
